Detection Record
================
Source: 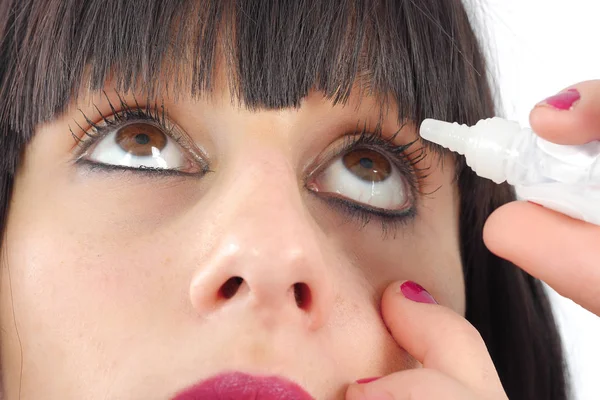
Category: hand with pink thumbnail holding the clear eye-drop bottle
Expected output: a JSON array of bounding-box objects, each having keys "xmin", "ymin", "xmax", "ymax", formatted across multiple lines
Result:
[{"xmin": 483, "ymin": 80, "xmax": 600, "ymax": 315}]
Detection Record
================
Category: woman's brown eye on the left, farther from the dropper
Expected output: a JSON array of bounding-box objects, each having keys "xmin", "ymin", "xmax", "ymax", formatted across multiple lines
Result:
[{"xmin": 81, "ymin": 121, "xmax": 203, "ymax": 174}]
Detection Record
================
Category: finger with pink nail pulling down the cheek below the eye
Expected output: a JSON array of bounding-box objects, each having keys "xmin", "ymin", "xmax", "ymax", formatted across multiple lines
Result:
[{"xmin": 381, "ymin": 281, "xmax": 501, "ymax": 393}]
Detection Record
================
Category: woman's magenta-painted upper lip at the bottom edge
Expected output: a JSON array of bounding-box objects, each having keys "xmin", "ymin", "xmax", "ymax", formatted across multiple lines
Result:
[{"xmin": 172, "ymin": 372, "xmax": 315, "ymax": 400}]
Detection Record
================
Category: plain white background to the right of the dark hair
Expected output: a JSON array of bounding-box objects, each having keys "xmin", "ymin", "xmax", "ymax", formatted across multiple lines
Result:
[{"xmin": 474, "ymin": 0, "xmax": 600, "ymax": 400}]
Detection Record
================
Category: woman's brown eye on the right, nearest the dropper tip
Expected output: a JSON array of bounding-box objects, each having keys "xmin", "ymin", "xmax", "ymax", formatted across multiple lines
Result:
[{"xmin": 310, "ymin": 148, "xmax": 412, "ymax": 212}]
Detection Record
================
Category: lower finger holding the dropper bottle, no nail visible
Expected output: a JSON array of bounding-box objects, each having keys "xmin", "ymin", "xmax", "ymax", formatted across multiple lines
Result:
[{"xmin": 483, "ymin": 202, "xmax": 600, "ymax": 315}]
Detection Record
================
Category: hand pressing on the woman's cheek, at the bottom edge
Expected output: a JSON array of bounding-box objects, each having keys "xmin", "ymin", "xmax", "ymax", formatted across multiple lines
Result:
[{"xmin": 346, "ymin": 282, "xmax": 506, "ymax": 400}]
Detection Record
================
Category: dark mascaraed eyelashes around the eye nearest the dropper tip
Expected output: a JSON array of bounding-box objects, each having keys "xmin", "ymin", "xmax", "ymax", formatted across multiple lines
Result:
[{"xmin": 310, "ymin": 125, "xmax": 428, "ymax": 239}]
